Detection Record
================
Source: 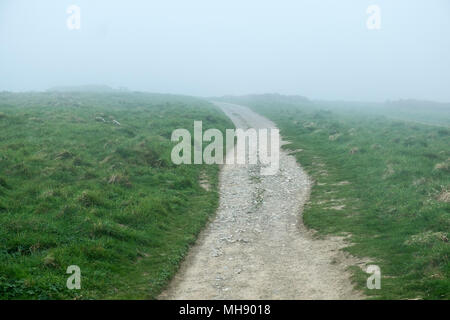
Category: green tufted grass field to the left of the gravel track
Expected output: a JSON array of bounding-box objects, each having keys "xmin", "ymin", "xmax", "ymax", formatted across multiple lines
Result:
[{"xmin": 0, "ymin": 92, "xmax": 233, "ymax": 299}]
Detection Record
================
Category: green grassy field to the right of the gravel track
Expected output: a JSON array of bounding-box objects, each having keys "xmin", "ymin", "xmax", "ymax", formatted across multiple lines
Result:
[{"xmin": 221, "ymin": 95, "xmax": 450, "ymax": 299}]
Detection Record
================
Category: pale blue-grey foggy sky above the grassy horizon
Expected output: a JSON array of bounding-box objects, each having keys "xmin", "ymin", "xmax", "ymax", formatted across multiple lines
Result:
[{"xmin": 0, "ymin": 0, "xmax": 450, "ymax": 102}]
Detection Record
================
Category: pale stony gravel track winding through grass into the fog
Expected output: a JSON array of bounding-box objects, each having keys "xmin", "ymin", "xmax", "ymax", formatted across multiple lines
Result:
[{"xmin": 159, "ymin": 103, "xmax": 363, "ymax": 299}]
